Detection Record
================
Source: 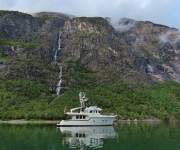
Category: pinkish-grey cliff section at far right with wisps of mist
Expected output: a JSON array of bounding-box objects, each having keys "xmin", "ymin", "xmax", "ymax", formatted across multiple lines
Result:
[{"xmin": 115, "ymin": 19, "xmax": 180, "ymax": 82}]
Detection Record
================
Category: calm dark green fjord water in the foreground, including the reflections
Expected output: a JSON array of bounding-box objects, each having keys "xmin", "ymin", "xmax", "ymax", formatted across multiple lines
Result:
[{"xmin": 0, "ymin": 122, "xmax": 180, "ymax": 150}]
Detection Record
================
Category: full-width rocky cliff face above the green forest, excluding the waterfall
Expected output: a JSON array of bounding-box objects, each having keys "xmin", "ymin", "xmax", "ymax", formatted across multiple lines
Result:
[{"xmin": 0, "ymin": 11, "xmax": 180, "ymax": 93}]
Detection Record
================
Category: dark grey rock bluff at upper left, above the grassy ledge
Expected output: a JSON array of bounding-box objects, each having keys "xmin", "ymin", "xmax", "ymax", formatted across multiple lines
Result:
[{"xmin": 0, "ymin": 12, "xmax": 43, "ymax": 42}]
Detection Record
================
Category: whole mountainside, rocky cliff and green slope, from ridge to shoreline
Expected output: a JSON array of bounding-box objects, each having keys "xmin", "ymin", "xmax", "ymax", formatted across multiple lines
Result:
[{"xmin": 0, "ymin": 11, "xmax": 180, "ymax": 119}]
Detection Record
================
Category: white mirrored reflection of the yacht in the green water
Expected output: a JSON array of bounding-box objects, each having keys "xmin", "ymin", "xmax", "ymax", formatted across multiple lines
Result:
[{"xmin": 59, "ymin": 126, "xmax": 118, "ymax": 150}]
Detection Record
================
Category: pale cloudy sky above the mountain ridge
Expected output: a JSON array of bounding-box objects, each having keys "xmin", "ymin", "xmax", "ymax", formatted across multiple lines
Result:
[{"xmin": 0, "ymin": 0, "xmax": 180, "ymax": 29}]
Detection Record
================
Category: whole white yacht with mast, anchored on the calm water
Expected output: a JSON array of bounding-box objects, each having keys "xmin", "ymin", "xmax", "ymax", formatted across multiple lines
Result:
[{"xmin": 57, "ymin": 92, "xmax": 116, "ymax": 126}]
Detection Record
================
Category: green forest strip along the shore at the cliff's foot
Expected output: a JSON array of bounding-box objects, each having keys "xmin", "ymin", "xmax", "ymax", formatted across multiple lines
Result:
[{"xmin": 0, "ymin": 74, "xmax": 180, "ymax": 120}]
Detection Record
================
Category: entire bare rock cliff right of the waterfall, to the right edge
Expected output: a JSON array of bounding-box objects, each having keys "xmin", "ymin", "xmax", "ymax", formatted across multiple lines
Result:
[{"xmin": 60, "ymin": 18, "xmax": 180, "ymax": 84}]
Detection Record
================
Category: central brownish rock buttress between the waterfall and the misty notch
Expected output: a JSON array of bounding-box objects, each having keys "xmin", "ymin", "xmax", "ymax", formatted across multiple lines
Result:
[{"xmin": 59, "ymin": 17, "xmax": 131, "ymax": 84}]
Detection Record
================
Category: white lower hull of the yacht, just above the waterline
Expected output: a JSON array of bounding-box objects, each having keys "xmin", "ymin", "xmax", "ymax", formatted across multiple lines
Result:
[{"xmin": 57, "ymin": 116, "xmax": 115, "ymax": 127}]
